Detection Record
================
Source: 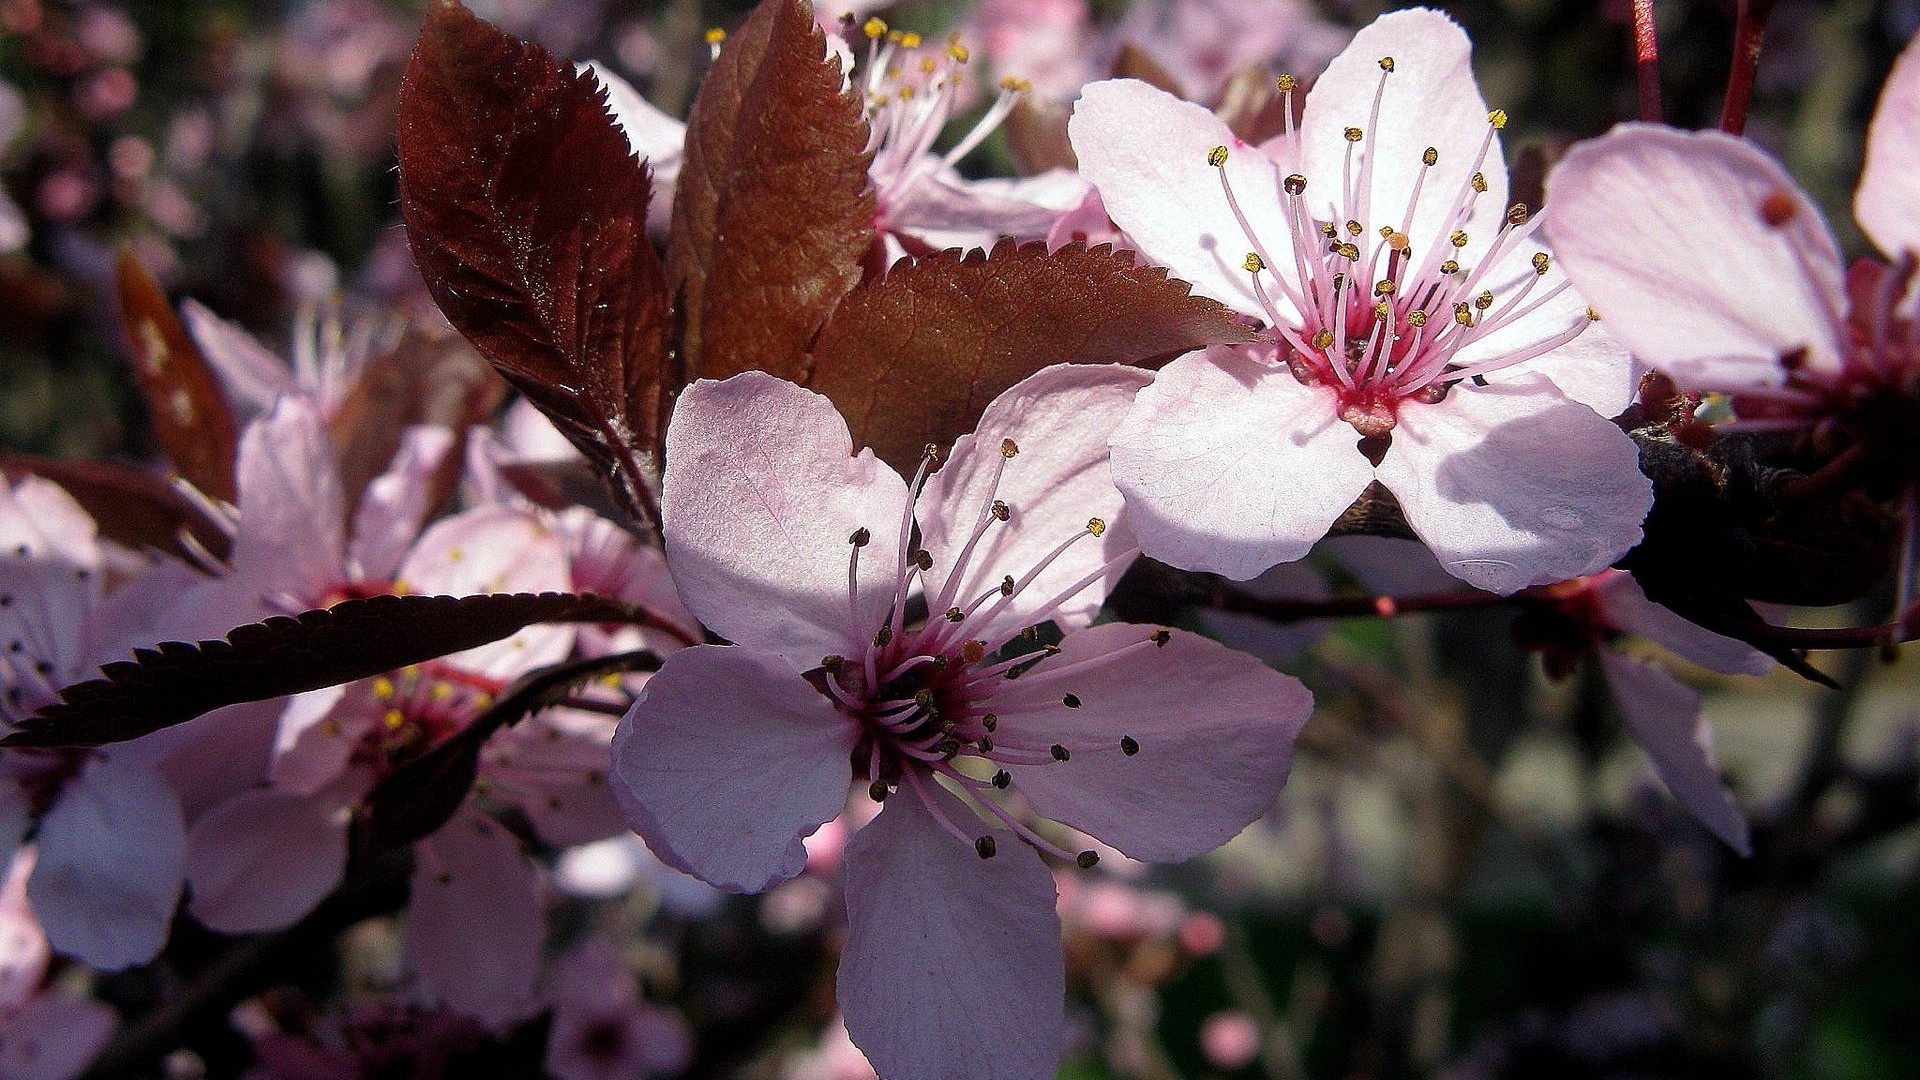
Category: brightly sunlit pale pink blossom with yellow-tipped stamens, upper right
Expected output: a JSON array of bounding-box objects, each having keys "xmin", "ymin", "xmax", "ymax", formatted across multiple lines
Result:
[{"xmin": 1069, "ymin": 10, "xmax": 1653, "ymax": 592}]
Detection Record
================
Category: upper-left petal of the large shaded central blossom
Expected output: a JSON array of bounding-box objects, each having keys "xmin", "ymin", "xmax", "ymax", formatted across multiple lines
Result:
[{"xmin": 660, "ymin": 371, "xmax": 906, "ymax": 671}]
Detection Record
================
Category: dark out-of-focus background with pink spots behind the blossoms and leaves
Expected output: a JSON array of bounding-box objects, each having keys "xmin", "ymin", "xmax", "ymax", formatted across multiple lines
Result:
[{"xmin": 0, "ymin": 0, "xmax": 1920, "ymax": 1080}]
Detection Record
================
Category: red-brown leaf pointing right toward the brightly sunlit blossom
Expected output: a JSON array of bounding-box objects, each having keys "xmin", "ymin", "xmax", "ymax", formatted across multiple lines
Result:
[{"xmin": 808, "ymin": 240, "xmax": 1252, "ymax": 469}]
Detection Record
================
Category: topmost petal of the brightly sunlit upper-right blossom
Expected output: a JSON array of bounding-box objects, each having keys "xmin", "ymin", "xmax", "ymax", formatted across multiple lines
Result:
[{"xmin": 1283, "ymin": 8, "xmax": 1507, "ymax": 265}]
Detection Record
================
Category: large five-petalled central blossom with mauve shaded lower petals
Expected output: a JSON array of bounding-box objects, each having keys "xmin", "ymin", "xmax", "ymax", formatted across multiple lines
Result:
[{"xmin": 614, "ymin": 365, "xmax": 1311, "ymax": 1078}]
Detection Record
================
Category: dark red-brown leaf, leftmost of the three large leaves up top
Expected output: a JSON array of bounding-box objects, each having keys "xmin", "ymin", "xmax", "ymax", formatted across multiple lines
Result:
[{"xmin": 399, "ymin": 0, "xmax": 666, "ymax": 507}]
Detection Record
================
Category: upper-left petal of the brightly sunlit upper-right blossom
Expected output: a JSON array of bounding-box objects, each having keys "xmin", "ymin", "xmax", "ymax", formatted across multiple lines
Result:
[{"xmin": 1068, "ymin": 79, "xmax": 1292, "ymax": 315}]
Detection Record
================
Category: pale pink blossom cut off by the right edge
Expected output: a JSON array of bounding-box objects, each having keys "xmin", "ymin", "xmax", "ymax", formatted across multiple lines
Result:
[{"xmin": 1548, "ymin": 29, "xmax": 1920, "ymax": 622}]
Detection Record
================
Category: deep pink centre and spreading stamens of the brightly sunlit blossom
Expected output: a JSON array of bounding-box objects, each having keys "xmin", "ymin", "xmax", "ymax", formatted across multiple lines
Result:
[{"xmin": 1208, "ymin": 56, "xmax": 1594, "ymax": 438}]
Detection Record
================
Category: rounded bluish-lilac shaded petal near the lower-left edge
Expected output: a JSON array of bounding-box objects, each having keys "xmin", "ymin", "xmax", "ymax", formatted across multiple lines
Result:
[{"xmin": 27, "ymin": 759, "xmax": 186, "ymax": 970}]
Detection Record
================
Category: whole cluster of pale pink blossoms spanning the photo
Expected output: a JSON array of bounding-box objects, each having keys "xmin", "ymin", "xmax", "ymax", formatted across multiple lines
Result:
[{"xmin": 0, "ymin": 4, "xmax": 1920, "ymax": 1080}]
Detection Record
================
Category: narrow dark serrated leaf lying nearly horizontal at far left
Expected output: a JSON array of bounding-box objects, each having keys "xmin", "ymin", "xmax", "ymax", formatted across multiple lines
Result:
[{"xmin": 0, "ymin": 592, "xmax": 647, "ymax": 746}]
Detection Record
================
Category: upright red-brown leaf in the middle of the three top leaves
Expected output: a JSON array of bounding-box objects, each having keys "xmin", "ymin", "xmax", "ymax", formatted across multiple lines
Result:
[{"xmin": 666, "ymin": 0, "xmax": 874, "ymax": 380}]
